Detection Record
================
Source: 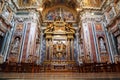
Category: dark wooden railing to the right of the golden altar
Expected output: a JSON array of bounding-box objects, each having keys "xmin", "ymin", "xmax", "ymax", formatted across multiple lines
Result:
[{"xmin": 79, "ymin": 62, "xmax": 120, "ymax": 73}]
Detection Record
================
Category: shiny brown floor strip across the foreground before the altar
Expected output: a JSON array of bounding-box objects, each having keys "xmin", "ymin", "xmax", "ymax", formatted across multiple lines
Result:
[{"xmin": 0, "ymin": 72, "xmax": 120, "ymax": 80}]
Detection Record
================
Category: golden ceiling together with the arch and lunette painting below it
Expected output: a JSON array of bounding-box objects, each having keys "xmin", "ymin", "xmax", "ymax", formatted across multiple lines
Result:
[{"xmin": 13, "ymin": 0, "xmax": 107, "ymax": 21}]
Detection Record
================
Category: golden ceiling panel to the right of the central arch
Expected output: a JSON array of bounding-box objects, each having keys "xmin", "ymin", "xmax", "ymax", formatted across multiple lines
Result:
[{"xmin": 83, "ymin": 0, "xmax": 106, "ymax": 8}]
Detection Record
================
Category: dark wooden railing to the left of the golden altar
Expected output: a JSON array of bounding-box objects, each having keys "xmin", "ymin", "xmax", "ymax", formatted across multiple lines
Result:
[{"xmin": 0, "ymin": 62, "xmax": 44, "ymax": 73}]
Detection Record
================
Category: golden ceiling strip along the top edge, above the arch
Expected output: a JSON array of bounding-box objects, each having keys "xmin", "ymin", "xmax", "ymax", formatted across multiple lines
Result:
[{"xmin": 13, "ymin": 0, "xmax": 108, "ymax": 10}]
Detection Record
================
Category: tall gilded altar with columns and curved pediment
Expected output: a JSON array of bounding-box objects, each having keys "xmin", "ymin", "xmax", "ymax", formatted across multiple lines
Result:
[{"xmin": 44, "ymin": 19, "xmax": 75, "ymax": 71}]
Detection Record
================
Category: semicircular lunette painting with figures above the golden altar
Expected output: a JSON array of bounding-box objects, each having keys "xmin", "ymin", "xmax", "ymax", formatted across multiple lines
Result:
[{"xmin": 45, "ymin": 8, "xmax": 75, "ymax": 21}]
